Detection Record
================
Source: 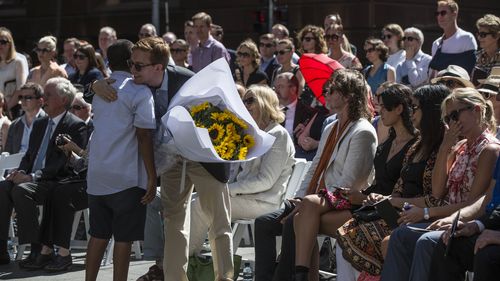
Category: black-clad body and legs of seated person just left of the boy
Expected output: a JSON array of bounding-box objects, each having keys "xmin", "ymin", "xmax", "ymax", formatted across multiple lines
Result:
[{"xmin": 26, "ymin": 135, "xmax": 88, "ymax": 272}]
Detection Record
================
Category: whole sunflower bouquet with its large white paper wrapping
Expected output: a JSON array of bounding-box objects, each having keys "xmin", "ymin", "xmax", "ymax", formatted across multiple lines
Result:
[{"xmin": 155, "ymin": 59, "xmax": 275, "ymax": 173}]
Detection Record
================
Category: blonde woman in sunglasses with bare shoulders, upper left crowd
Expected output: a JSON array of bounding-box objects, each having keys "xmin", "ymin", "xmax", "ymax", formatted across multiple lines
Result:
[{"xmin": 28, "ymin": 35, "xmax": 68, "ymax": 87}]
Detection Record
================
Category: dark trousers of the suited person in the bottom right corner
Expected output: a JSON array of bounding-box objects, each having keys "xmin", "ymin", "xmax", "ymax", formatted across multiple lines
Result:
[{"xmin": 429, "ymin": 235, "xmax": 500, "ymax": 281}]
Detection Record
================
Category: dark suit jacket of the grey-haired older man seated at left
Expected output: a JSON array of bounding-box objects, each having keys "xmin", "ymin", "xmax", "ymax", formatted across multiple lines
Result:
[{"xmin": 19, "ymin": 112, "xmax": 87, "ymax": 180}]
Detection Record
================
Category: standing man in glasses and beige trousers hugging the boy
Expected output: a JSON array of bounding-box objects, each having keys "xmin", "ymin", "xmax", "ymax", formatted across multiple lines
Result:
[{"xmin": 92, "ymin": 35, "xmax": 234, "ymax": 281}]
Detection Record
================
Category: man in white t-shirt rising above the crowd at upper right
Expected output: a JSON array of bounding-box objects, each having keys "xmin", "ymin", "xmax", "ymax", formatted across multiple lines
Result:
[{"xmin": 430, "ymin": 0, "xmax": 477, "ymax": 78}]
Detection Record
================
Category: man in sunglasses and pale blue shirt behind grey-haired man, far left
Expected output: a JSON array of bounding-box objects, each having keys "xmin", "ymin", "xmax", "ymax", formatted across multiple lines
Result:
[{"xmin": 4, "ymin": 82, "xmax": 47, "ymax": 154}]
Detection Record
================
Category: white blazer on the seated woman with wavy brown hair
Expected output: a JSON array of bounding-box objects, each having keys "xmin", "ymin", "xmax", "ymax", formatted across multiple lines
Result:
[{"xmin": 298, "ymin": 119, "xmax": 377, "ymax": 195}]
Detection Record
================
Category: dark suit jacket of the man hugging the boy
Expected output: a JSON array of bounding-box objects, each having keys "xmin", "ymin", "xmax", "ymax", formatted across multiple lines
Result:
[{"xmin": 167, "ymin": 65, "xmax": 230, "ymax": 183}]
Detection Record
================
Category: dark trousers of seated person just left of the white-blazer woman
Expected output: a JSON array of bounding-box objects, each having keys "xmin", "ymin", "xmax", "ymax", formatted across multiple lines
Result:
[{"xmin": 255, "ymin": 209, "xmax": 295, "ymax": 281}]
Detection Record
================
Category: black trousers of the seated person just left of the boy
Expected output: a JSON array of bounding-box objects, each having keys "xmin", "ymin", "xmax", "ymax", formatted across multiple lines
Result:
[{"xmin": 40, "ymin": 181, "xmax": 88, "ymax": 249}]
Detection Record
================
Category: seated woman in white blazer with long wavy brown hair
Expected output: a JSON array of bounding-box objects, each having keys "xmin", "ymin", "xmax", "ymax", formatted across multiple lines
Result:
[{"xmin": 294, "ymin": 69, "xmax": 377, "ymax": 281}]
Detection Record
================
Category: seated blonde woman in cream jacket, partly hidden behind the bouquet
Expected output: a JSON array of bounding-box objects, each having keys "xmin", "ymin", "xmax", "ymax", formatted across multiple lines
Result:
[{"xmin": 189, "ymin": 85, "xmax": 295, "ymax": 254}]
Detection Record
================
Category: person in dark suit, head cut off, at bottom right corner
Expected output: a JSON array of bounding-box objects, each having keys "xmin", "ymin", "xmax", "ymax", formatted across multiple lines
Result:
[{"xmin": 429, "ymin": 176, "xmax": 500, "ymax": 281}]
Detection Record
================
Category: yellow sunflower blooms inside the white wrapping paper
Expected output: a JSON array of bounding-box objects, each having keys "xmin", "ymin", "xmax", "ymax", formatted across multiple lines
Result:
[{"xmin": 190, "ymin": 102, "xmax": 255, "ymax": 160}]
